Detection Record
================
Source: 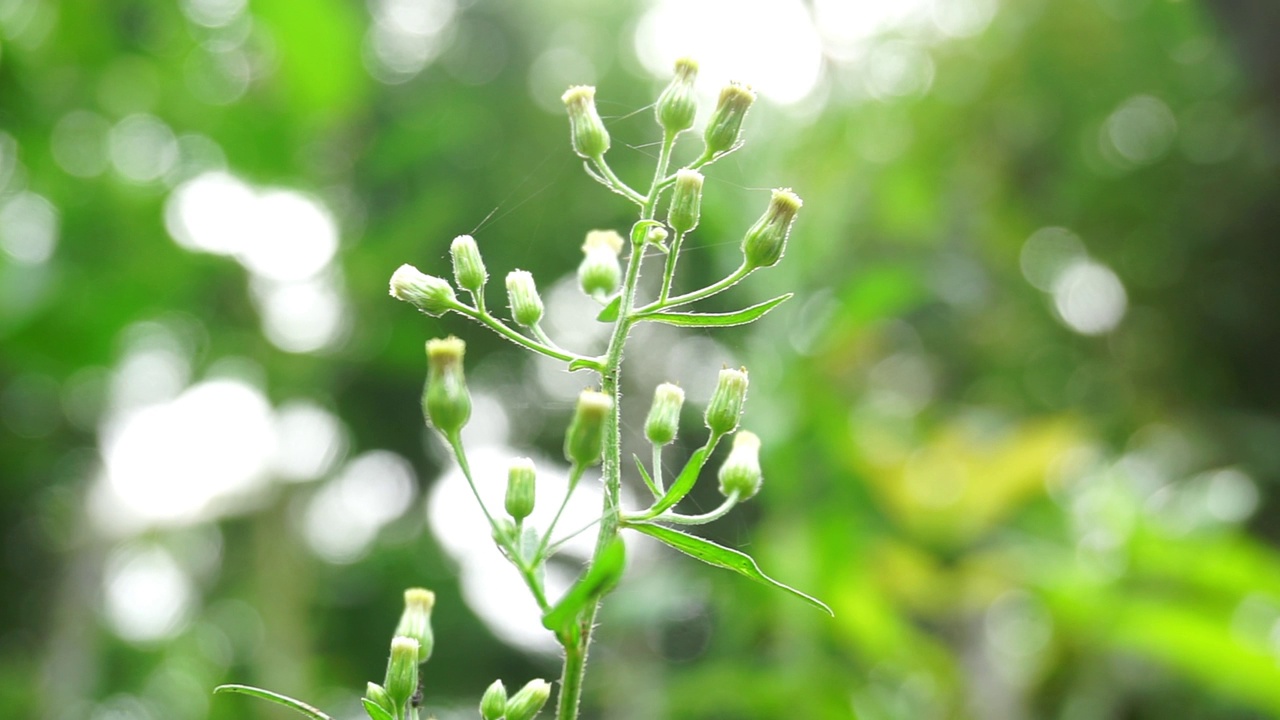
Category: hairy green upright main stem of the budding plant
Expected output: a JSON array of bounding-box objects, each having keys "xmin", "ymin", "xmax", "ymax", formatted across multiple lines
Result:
[{"xmin": 556, "ymin": 133, "xmax": 676, "ymax": 720}]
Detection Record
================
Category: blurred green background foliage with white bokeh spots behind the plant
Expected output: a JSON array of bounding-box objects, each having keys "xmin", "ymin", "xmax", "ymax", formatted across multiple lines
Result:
[{"xmin": 0, "ymin": 0, "xmax": 1280, "ymax": 720}]
